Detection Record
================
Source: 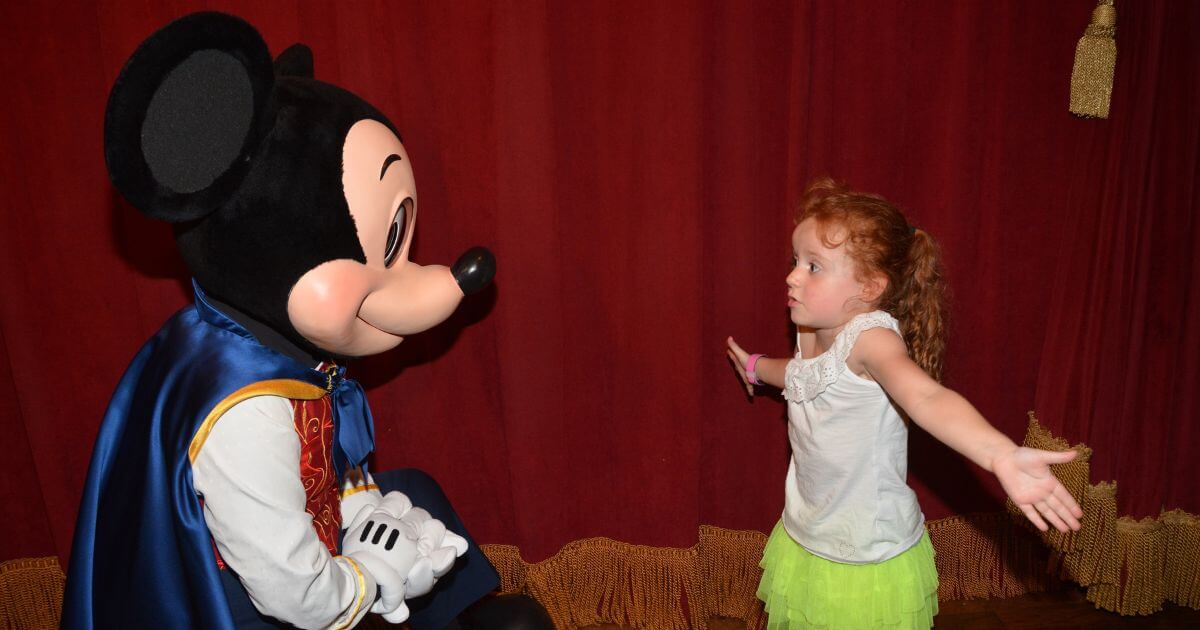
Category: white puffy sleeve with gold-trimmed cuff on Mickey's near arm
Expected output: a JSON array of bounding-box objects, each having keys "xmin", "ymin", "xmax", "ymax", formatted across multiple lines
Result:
[{"xmin": 192, "ymin": 396, "xmax": 376, "ymax": 628}]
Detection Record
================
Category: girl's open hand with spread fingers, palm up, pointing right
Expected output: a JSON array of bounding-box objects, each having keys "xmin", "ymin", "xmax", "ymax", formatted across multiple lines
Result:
[{"xmin": 991, "ymin": 446, "xmax": 1084, "ymax": 532}]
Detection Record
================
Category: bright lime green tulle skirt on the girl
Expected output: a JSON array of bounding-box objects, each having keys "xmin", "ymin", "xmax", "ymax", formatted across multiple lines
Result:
[{"xmin": 758, "ymin": 522, "xmax": 937, "ymax": 630}]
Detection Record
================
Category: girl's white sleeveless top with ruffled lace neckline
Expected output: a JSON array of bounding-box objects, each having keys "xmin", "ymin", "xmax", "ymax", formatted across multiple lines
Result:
[{"xmin": 784, "ymin": 311, "xmax": 925, "ymax": 564}]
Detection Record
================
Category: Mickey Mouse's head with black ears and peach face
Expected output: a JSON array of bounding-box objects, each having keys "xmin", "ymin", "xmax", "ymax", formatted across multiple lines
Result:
[{"xmin": 104, "ymin": 13, "xmax": 496, "ymax": 356}]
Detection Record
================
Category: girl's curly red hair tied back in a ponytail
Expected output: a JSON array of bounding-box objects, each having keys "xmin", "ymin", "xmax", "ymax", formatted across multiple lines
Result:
[{"xmin": 797, "ymin": 178, "xmax": 946, "ymax": 379}]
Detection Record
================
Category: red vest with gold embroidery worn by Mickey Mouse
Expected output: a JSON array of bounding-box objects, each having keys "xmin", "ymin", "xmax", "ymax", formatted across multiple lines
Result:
[{"xmin": 212, "ymin": 395, "xmax": 342, "ymax": 569}]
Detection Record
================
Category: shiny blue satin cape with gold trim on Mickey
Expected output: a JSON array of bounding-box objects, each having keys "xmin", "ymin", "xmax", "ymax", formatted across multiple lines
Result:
[{"xmin": 61, "ymin": 283, "xmax": 374, "ymax": 629}]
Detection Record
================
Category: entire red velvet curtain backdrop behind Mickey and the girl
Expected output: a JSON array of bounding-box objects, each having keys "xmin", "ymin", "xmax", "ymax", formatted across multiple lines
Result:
[{"xmin": 0, "ymin": 0, "xmax": 1200, "ymax": 560}]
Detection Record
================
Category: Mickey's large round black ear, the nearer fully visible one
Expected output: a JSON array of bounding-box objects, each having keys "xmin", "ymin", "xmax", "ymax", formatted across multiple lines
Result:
[{"xmin": 104, "ymin": 12, "xmax": 275, "ymax": 223}]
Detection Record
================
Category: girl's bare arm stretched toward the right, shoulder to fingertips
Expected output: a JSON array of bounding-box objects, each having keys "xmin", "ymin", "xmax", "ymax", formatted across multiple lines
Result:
[{"xmin": 846, "ymin": 329, "xmax": 1084, "ymax": 532}]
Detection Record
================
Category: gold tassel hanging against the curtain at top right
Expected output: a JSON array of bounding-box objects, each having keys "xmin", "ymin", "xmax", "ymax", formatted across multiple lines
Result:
[{"xmin": 1070, "ymin": 0, "xmax": 1117, "ymax": 118}]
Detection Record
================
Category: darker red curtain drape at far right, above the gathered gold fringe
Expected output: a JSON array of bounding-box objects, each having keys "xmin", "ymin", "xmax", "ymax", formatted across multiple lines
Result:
[{"xmin": 1034, "ymin": 2, "xmax": 1200, "ymax": 518}]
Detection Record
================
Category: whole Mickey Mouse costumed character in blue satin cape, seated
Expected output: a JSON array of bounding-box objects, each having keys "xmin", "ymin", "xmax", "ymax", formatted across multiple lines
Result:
[{"xmin": 62, "ymin": 13, "xmax": 548, "ymax": 629}]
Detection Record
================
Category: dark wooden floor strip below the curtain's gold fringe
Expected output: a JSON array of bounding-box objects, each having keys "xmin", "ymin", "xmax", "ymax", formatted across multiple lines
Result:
[{"xmin": 934, "ymin": 587, "xmax": 1200, "ymax": 630}]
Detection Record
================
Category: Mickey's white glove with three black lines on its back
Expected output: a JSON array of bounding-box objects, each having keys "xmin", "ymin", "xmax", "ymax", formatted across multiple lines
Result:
[{"xmin": 342, "ymin": 492, "xmax": 467, "ymax": 624}]
